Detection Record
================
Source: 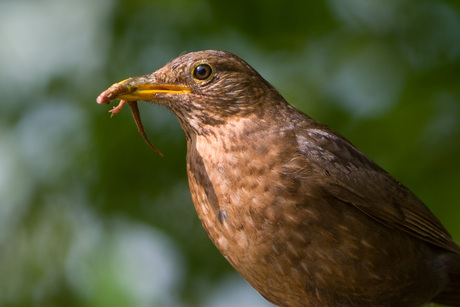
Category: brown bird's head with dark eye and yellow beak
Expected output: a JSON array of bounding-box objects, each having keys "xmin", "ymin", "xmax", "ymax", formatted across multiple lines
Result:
[{"xmin": 98, "ymin": 50, "xmax": 279, "ymax": 134}]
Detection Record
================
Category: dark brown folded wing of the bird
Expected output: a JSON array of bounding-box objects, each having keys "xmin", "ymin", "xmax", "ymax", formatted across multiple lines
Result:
[{"xmin": 297, "ymin": 125, "xmax": 460, "ymax": 254}]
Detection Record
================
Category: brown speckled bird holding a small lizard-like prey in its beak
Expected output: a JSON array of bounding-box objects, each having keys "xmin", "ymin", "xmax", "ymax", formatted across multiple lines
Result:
[{"xmin": 98, "ymin": 50, "xmax": 460, "ymax": 306}]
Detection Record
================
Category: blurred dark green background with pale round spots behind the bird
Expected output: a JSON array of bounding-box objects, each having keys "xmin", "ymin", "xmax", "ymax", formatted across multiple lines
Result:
[{"xmin": 0, "ymin": 0, "xmax": 460, "ymax": 307}]
